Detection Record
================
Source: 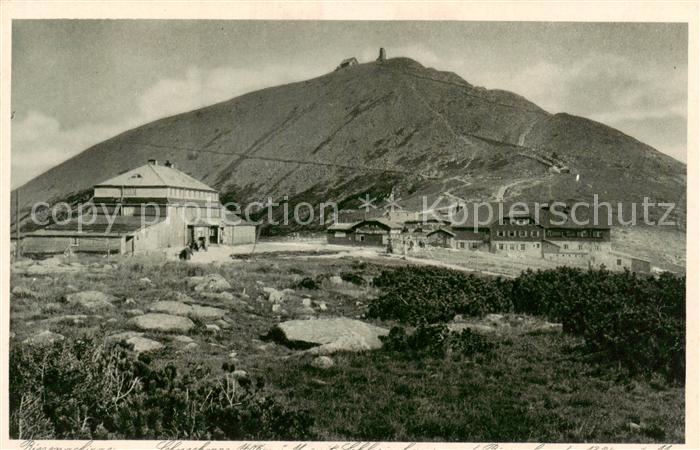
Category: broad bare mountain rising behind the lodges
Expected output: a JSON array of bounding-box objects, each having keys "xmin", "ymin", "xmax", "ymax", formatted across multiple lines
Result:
[{"xmin": 13, "ymin": 58, "xmax": 686, "ymax": 229}]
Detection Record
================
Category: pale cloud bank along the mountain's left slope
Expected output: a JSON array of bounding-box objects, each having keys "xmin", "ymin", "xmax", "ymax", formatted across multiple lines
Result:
[{"xmin": 11, "ymin": 65, "xmax": 321, "ymax": 187}]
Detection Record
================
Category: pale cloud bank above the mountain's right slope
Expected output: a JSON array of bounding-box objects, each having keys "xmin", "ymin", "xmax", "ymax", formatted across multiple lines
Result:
[{"xmin": 474, "ymin": 54, "xmax": 687, "ymax": 161}]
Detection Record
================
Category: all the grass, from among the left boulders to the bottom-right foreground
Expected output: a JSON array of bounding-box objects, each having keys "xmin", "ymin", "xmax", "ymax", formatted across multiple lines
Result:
[{"xmin": 10, "ymin": 254, "xmax": 685, "ymax": 442}]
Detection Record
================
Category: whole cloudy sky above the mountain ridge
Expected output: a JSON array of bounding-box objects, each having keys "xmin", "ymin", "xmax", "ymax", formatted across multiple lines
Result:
[{"xmin": 11, "ymin": 20, "xmax": 688, "ymax": 188}]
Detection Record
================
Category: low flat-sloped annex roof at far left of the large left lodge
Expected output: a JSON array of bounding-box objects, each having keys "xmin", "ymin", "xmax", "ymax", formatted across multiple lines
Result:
[{"xmin": 27, "ymin": 215, "xmax": 165, "ymax": 235}]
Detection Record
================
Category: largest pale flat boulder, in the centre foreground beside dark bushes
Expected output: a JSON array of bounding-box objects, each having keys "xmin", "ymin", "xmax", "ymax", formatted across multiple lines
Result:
[{"xmin": 271, "ymin": 317, "xmax": 389, "ymax": 354}]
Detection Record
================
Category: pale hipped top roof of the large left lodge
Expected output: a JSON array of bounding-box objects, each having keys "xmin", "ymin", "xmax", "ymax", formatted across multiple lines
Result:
[{"xmin": 95, "ymin": 164, "xmax": 216, "ymax": 192}]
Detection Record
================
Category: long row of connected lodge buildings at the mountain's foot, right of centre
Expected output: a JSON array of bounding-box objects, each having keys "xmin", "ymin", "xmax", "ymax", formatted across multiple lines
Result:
[{"xmin": 328, "ymin": 204, "xmax": 651, "ymax": 272}]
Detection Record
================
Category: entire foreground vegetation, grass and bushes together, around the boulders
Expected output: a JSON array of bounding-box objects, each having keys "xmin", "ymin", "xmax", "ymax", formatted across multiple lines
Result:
[{"xmin": 10, "ymin": 256, "xmax": 685, "ymax": 442}]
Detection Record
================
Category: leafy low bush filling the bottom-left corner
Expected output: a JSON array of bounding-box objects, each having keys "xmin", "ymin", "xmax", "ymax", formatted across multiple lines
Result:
[{"xmin": 10, "ymin": 338, "xmax": 312, "ymax": 440}]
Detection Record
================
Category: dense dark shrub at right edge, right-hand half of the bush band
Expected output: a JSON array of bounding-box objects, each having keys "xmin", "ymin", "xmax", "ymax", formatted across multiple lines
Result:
[{"xmin": 512, "ymin": 267, "xmax": 685, "ymax": 381}]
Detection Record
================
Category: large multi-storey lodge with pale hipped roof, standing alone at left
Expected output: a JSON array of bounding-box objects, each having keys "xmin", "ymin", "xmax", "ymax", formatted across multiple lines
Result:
[{"xmin": 21, "ymin": 160, "xmax": 256, "ymax": 254}]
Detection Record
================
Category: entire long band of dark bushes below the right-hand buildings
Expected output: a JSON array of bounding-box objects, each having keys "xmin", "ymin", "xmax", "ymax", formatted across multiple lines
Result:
[{"xmin": 368, "ymin": 267, "xmax": 685, "ymax": 381}]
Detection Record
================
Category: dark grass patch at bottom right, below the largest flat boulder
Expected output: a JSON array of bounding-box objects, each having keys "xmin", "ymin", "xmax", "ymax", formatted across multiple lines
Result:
[{"xmin": 270, "ymin": 335, "xmax": 683, "ymax": 442}]
